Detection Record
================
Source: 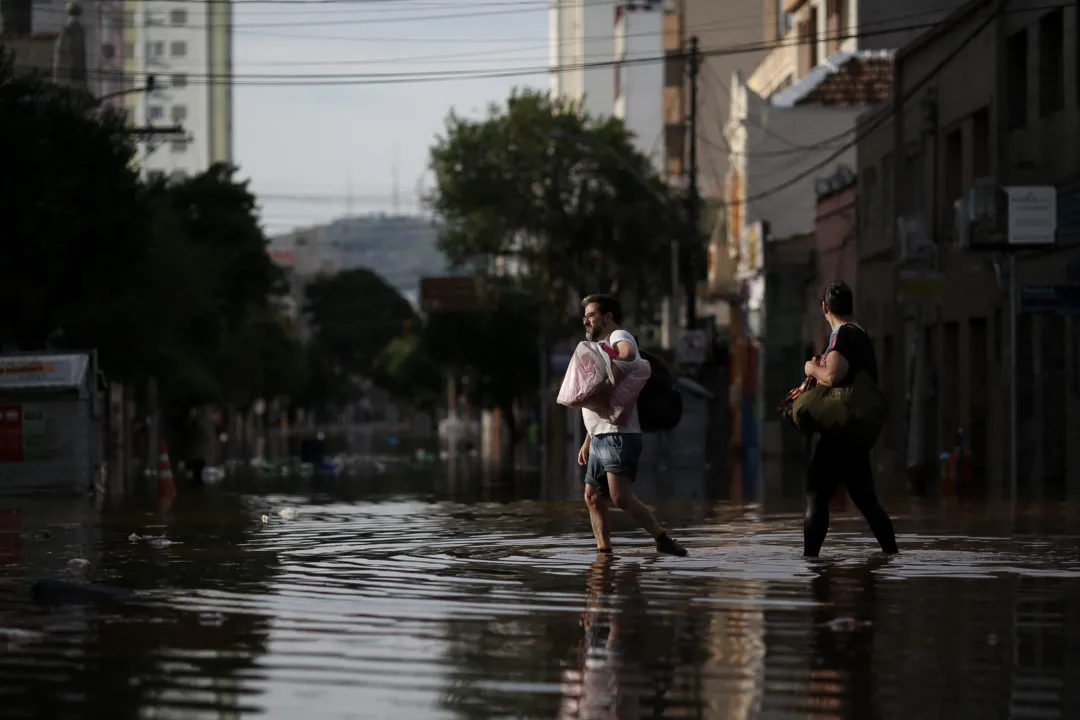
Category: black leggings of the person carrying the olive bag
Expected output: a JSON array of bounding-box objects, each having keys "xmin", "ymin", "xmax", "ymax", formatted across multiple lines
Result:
[{"xmin": 802, "ymin": 435, "xmax": 900, "ymax": 557}]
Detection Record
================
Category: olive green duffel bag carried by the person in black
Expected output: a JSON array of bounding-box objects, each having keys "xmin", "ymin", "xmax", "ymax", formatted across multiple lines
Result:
[{"xmin": 792, "ymin": 372, "xmax": 889, "ymax": 449}]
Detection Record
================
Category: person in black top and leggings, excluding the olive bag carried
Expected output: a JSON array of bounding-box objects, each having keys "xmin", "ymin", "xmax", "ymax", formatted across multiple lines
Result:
[{"xmin": 802, "ymin": 282, "xmax": 900, "ymax": 557}]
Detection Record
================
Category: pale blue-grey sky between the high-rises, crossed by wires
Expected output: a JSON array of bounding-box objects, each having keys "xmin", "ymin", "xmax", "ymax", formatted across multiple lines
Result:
[{"xmin": 233, "ymin": 0, "xmax": 549, "ymax": 234}]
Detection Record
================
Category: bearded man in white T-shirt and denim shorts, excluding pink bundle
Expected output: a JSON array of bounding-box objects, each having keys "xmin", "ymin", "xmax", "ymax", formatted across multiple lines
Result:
[{"xmin": 578, "ymin": 295, "xmax": 686, "ymax": 556}]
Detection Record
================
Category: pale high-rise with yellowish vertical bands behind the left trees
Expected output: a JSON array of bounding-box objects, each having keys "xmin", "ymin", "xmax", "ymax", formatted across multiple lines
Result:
[{"xmin": 123, "ymin": 0, "xmax": 232, "ymax": 178}]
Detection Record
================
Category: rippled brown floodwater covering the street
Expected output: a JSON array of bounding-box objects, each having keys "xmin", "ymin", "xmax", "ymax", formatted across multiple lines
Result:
[{"xmin": 0, "ymin": 468, "xmax": 1080, "ymax": 720}]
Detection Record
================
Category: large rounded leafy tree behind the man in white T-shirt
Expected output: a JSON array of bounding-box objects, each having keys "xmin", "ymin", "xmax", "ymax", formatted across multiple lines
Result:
[{"xmin": 428, "ymin": 91, "xmax": 685, "ymax": 330}]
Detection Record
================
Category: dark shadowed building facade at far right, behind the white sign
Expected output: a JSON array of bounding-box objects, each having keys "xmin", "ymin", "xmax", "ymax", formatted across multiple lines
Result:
[{"xmin": 856, "ymin": 0, "xmax": 1080, "ymax": 497}]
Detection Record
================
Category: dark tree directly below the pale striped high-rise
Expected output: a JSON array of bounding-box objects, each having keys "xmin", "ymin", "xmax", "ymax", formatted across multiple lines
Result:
[{"xmin": 147, "ymin": 164, "xmax": 308, "ymax": 453}]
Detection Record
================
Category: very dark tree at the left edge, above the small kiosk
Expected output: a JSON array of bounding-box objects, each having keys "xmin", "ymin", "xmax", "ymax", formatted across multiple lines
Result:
[{"xmin": 0, "ymin": 47, "xmax": 148, "ymax": 360}]
